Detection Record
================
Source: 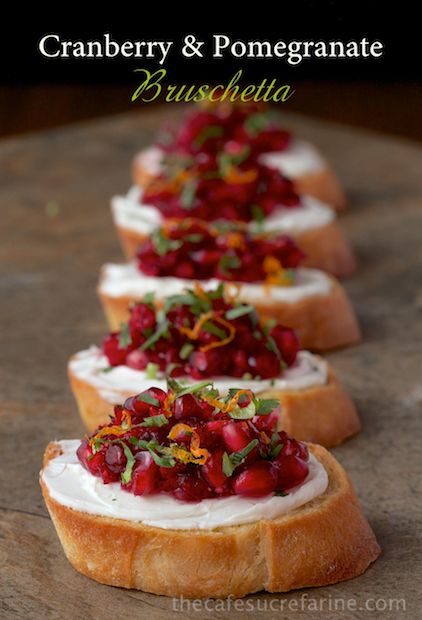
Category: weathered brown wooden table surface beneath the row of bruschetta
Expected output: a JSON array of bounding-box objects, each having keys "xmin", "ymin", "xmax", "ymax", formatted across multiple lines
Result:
[{"xmin": 0, "ymin": 107, "xmax": 422, "ymax": 620}]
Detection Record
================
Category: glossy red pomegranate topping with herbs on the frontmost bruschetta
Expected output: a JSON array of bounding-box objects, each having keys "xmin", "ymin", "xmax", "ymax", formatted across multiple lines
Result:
[{"xmin": 77, "ymin": 386, "xmax": 309, "ymax": 502}]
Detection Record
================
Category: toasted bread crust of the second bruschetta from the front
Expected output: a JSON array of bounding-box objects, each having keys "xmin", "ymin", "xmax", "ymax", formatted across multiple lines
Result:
[{"xmin": 68, "ymin": 366, "xmax": 361, "ymax": 448}]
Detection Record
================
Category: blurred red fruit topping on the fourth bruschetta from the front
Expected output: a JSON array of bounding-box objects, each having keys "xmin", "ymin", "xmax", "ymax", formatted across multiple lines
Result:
[{"xmin": 142, "ymin": 156, "xmax": 300, "ymax": 222}]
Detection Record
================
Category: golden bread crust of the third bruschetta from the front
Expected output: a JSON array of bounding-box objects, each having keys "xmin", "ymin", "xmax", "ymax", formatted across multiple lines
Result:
[{"xmin": 98, "ymin": 278, "xmax": 361, "ymax": 351}]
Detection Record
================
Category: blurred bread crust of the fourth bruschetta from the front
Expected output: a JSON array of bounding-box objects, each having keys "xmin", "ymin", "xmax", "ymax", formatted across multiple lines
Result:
[{"xmin": 116, "ymin": 222, "xmax": 357, "ymax": 278}]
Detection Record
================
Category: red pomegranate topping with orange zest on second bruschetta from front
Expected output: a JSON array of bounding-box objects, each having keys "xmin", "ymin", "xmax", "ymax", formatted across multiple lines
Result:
[{"xmin": 103, "ymin": 284, "xmax": 300, "ymax": 380}]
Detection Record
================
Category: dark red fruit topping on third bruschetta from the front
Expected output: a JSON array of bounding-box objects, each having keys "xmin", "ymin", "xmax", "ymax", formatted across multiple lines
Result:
[{"xmin": 137, "ymin": 219, "xmax": 304, "ymax": 285}]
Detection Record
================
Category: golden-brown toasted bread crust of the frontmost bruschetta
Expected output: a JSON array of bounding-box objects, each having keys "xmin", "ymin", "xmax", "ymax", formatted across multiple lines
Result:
[{"xmin": 40, "ymin": 444, "xmax": 380, "ymax": 598}]
